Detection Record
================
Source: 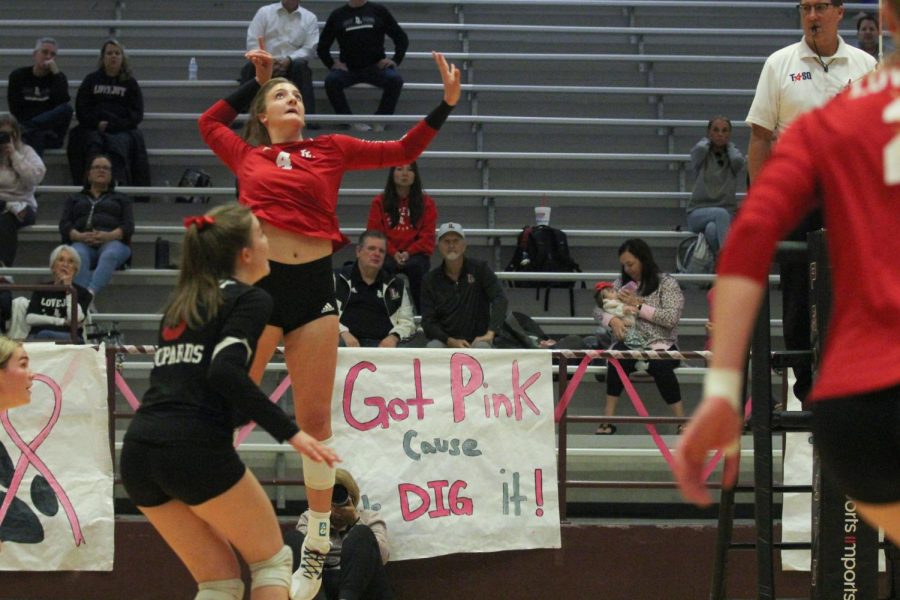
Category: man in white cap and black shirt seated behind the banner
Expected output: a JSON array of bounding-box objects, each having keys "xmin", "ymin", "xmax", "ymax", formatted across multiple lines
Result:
[{"xmin": 422, "ymin": 223, "xmax": 509, "ymax": 348}]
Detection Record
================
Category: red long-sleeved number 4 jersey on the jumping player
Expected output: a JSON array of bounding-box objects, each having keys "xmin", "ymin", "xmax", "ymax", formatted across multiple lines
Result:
[{"xmin": 198, "ymin": 100, "xmax": 437, "ymax": 249}]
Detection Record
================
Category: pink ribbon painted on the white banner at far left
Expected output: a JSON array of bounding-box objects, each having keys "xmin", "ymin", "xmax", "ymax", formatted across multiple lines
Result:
[{"xmin": 0, "ymin": 375, "xmax": 84, "ymax": 546}]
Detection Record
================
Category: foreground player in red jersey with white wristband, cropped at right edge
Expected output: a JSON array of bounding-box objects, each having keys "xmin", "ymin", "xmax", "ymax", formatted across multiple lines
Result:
[{"xmin": 675, "ymin": 0, "xmax": 900, "ymax": 543}]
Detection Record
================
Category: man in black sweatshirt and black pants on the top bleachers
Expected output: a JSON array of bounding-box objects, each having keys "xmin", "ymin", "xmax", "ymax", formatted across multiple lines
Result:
[{"xmin": 317, "ymin": 0, "xmax": 409, "ymax": 130}]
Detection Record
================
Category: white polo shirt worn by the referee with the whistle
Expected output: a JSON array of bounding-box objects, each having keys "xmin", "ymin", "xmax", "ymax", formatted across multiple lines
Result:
[{"xmin": 747, "ymin": 36, "xmax": 876, "ymax": 134}]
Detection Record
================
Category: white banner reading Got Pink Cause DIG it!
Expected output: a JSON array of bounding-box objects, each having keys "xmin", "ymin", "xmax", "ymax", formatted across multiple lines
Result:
[{"xmin": 332, "ymin": 348, "xmax": 560, "ymax": 560}]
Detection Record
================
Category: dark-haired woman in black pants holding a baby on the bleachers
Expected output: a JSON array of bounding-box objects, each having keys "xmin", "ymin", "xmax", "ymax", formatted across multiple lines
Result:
[{"xmin": 594, "ymin": 238, "xmax": 684, "ymax": 435}]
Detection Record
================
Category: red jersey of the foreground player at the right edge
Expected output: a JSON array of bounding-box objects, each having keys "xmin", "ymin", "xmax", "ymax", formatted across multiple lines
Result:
[{"xmin": 718, "ymin": 67, "xmax": 900, "ymax": 400}]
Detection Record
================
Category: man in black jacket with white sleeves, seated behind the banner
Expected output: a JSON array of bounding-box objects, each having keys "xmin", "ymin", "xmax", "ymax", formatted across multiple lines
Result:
[{"xmin": 334, "ymin": 230, "xmax": 416, "ymax": 348}]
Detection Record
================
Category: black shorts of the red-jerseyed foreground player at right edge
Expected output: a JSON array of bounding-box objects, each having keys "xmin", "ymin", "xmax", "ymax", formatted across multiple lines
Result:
[{"xmin": 812, "ymin": 387, "xmax": 900, "ymax": 504}]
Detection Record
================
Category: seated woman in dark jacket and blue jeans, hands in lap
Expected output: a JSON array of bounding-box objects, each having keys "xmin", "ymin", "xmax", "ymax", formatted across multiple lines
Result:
[{"xmin": 59, "ymin": 154, "xmax": 134, "ymax": 296}]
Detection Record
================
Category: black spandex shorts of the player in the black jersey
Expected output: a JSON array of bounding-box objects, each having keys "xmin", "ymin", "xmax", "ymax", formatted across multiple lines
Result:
[{"xmin": 119, "ymin": 437, "xmax": 246, "ymax": 507}]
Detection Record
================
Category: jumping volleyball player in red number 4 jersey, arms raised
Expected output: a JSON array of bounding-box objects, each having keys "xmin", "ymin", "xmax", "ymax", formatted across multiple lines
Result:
[{"xmin": 199, "ymin": 39, "xmax": 460, "ymax": 600}]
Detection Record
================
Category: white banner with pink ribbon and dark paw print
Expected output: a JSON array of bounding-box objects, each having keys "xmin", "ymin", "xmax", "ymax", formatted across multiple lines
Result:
[{"xmin": 0, "ymin": 344, "xmax": 114, "ymax": 571}]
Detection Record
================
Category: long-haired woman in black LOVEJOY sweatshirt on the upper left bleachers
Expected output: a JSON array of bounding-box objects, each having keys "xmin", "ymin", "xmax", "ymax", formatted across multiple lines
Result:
[{"xmin": 68, "ymin": 40, "xmax": 150, "ymax": 186}]
